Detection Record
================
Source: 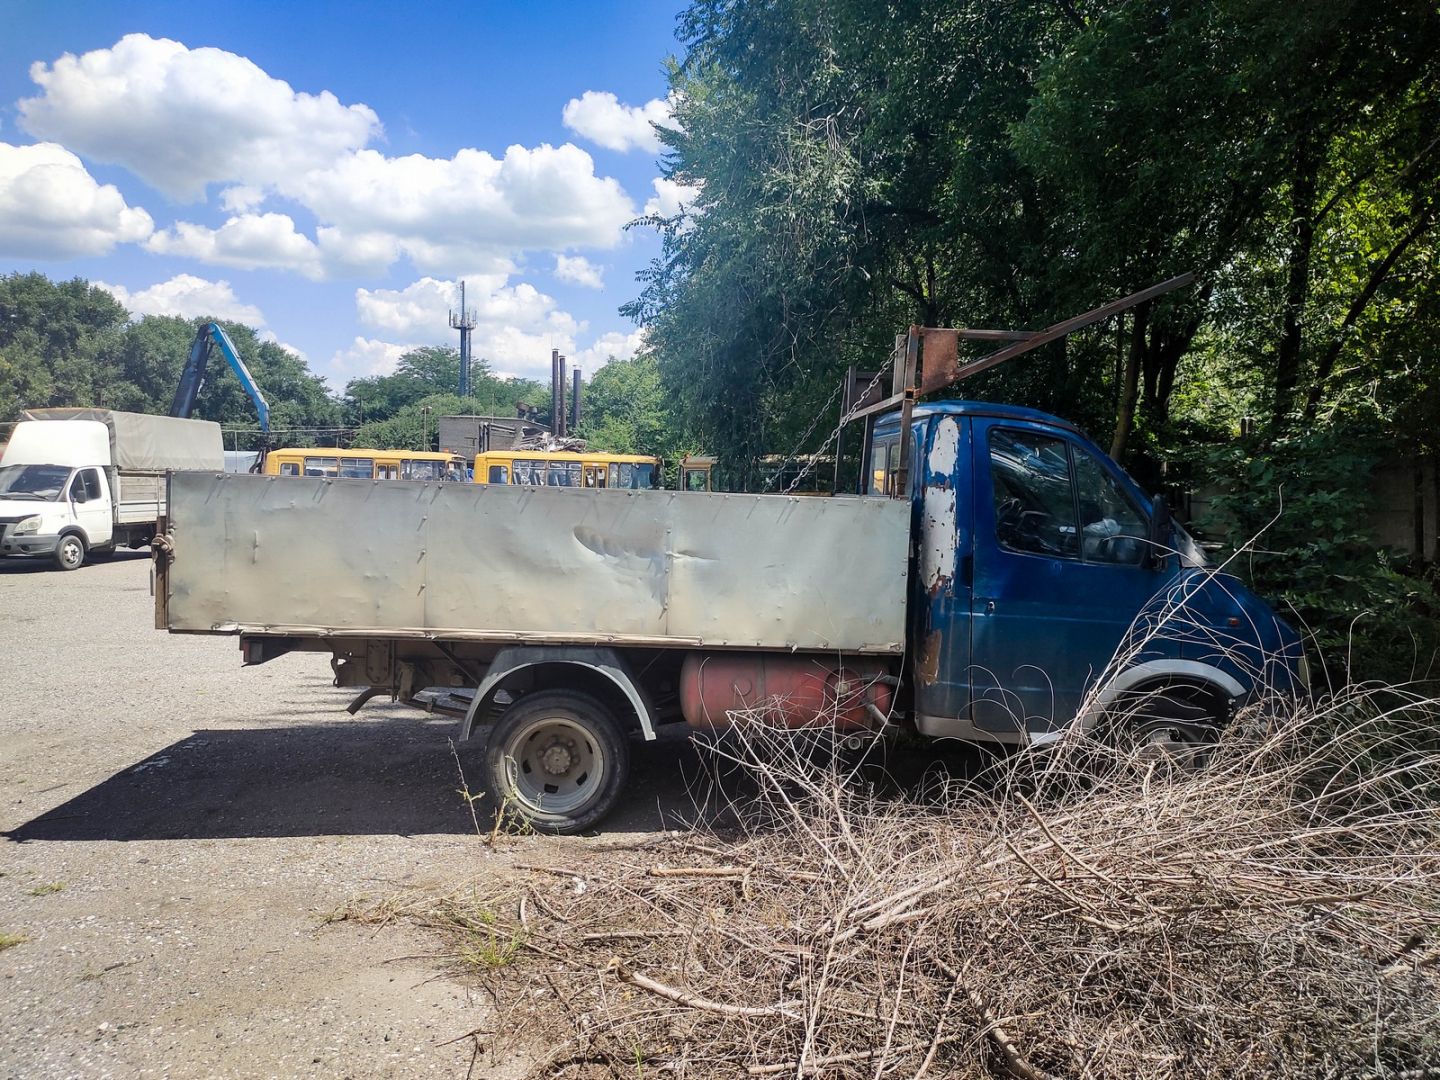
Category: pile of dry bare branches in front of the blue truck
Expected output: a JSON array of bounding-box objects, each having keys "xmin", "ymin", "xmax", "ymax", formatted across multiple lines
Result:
[{"xmin": 368, "ymin": 693, "xmax": 1440, "ymax": 1080}]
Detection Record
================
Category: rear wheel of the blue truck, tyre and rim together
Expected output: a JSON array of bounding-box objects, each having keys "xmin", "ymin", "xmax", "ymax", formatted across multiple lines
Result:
[{"xmin": 485, "ymin": 690, "xmax": 629, "ymax": 835}]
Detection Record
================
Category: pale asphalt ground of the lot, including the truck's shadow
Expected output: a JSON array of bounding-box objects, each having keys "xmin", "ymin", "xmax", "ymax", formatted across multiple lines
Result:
[{"xmin": 0, "ymin": 553, "xmax": 697, "ymax": 1079}]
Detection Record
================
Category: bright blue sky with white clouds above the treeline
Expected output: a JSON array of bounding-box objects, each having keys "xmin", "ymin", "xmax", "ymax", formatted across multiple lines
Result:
[{"xmin": 0, "ymin": 0, "xmax": 693, "ymax": 389}]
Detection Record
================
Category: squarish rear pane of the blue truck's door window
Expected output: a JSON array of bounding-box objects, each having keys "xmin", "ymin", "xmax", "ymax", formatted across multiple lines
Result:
[{"xmin": 989, "ymin": 428, "xmax": 1080, "ymax": 559}]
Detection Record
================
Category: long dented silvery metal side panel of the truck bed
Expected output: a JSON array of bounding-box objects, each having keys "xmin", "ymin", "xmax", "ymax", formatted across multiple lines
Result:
[{"xmin": 157, "ymin": 472, "xmax": 910, "ymax": 654}]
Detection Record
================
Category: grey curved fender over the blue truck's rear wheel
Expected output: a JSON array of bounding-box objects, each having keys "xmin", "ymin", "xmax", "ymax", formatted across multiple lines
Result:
[{"xmin": 459, "ymin": 645, "xmax": 655, "ymax": 742}]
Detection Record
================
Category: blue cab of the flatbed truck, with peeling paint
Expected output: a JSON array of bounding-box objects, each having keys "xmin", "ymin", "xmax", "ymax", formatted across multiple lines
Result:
[{"xmin": 864, "ymin": 400, "xmax": 1302, "ymax": 744}]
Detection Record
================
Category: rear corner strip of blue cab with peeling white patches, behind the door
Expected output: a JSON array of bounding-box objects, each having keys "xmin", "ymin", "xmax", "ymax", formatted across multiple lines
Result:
[{"xmin": 910, "ymin": 415, "xmax": 973, "ymax": 733}]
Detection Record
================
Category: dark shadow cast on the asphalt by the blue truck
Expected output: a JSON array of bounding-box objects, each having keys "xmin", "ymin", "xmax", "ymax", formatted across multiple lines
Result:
[{"xmin": 0, "ymin": 713, "xmax": 969, "ymax": 842}]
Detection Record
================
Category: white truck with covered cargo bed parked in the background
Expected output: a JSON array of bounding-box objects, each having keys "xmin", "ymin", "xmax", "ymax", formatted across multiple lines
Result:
[{"xmin": 0, "ymin": 409, "xmax": 225, "ymax": 570}]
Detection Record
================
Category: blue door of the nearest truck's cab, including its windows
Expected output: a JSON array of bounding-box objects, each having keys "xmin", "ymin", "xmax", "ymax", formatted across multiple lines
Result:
[{"xmin": 971, "ymin": 418, "xmax": 1165, "ymax": 733}]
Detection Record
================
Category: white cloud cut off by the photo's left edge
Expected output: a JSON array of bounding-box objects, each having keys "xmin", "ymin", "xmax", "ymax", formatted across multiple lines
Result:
[{"xmin": 0, "ymin": 143, "xmax": 154, "ymax": 259}]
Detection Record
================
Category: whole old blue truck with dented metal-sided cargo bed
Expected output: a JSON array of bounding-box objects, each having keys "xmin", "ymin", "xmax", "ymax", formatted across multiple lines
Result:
[{"xmin": 156, "ymin": 364, "xmax": 1306, "ymax": 832}]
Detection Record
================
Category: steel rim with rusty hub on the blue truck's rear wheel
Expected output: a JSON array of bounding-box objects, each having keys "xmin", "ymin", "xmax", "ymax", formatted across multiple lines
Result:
[{"xmin": 504, "ymin": 716, "xmax": 606, "ymax": 815}]
